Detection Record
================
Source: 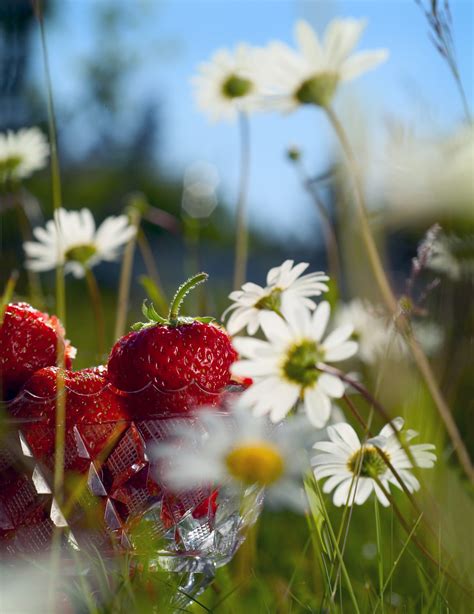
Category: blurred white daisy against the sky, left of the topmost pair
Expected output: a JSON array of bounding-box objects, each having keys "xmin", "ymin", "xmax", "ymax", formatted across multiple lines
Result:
[{"xmin": 192, "ymin": 44, "xmax": 261, "ymax": 121}]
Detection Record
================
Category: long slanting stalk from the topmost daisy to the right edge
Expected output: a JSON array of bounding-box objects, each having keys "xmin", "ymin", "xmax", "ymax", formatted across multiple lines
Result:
[{"xmin": 325, "ymin": 106, "xmax": 474, "ymax": 482}]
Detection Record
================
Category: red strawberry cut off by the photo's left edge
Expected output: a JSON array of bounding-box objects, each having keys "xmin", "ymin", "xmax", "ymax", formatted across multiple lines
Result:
[{"xmin": 0, "ymin": 303, "xmax": 76, "ymax": 399}]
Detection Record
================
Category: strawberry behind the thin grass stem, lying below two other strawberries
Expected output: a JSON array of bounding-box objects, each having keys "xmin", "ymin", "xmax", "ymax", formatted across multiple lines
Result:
[{"xmin": 12, "ymin": 367, "xmax": 127, "ymax": 471}]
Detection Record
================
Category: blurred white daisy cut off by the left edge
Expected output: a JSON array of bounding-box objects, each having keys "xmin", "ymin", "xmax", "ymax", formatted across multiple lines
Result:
[{"xmin": 0, "ymin": 128, "xmax": 49, "ymax": 180}]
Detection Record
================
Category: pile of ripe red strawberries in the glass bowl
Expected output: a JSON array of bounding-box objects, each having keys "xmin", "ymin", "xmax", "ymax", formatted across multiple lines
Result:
[{"xmin": 0, "ymin": 280, "xmax": 237, "ymax": 544}]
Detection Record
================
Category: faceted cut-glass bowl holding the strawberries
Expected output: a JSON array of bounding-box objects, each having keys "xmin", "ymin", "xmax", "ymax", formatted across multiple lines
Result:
[{"xmin": 0, "ymin": 384, "xmax": 263, "ymax": 606}]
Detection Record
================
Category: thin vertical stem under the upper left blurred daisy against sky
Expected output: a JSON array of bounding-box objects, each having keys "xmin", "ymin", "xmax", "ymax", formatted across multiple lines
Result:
[{"xmin": 234, "ymin": 112, "xmax": 250, "ymax": 289}]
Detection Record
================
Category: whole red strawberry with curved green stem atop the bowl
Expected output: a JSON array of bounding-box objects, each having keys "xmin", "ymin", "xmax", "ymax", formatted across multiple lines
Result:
[{"xmin": 108, "ymin": 273, "xmax": 237, "ymax": 418}]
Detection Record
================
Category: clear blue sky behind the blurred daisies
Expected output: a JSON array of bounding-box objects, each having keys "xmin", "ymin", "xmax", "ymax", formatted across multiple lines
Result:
[{"xmin": 33, "ymin": 0, "xmax": 474, "ymax": 238}]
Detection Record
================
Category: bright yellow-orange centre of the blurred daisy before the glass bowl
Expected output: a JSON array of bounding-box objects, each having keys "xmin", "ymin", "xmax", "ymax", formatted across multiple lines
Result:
[{"xmin": 225, "ymin": 441, "xmax": 284, "ymax": 486}]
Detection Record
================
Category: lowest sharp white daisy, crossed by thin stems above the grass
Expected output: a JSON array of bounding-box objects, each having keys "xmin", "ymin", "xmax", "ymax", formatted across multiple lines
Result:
[{"xmin": 311, "ymin": 418, "xmax": 436, "ymax": 506}]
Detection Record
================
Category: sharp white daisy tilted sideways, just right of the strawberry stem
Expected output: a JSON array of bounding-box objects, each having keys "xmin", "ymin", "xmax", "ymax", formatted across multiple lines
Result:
[{"xmin": 222, "ymin": 260, "xmax": 329, "ymax": 335}]
